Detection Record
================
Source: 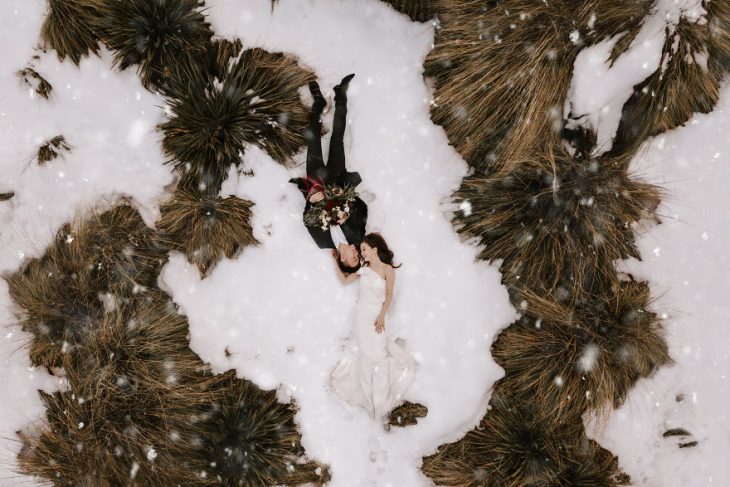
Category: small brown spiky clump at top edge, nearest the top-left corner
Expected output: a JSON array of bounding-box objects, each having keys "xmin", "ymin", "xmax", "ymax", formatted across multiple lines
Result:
[{"xmin": 41, "ymin": 0, "xmax": 102, "ymax": 66}]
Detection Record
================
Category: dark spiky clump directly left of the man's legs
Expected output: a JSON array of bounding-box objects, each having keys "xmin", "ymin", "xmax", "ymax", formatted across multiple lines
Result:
[{"xmin": 160, "ymin": 40, "xmax": 314, "ymax": 193}]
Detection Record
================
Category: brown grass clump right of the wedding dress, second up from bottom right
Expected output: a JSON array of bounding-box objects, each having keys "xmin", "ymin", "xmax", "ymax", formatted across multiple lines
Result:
[{"xmin": 492, "ymin": 281, "xmax": 672, "ymax": 424}]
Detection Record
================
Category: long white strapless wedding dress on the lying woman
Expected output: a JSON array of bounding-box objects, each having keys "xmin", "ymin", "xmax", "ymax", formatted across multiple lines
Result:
[{"xmin": 330, "ymin": 266, "xmax": 415, "ymax": 419}]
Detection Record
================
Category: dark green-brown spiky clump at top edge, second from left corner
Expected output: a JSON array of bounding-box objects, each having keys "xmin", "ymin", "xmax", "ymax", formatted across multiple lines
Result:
[{"xmin": 99, "ymin": 0, "xmax": 213, "ymax": 88}]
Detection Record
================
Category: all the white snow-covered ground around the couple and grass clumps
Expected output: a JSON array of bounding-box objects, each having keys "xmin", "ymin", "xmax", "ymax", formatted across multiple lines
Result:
[{"xmin": 0, "ymin": 0, "xmax": 730, "ymax": 487}]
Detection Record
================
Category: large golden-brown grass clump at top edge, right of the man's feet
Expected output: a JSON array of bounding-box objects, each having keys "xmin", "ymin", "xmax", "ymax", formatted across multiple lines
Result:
[{"xmin": 424, "ymin": 0, "xmax": 652, "ymax": 172}]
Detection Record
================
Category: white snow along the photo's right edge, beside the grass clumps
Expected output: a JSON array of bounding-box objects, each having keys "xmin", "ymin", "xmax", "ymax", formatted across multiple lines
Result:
[{"xmin": 594, "ymin": 82, "xmax": 730, "ymax": 487}]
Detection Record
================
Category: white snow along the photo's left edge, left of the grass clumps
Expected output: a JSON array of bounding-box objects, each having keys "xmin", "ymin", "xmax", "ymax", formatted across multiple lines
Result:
[{"xmin": 0, "ymin": 0, "xmax": 173, "ymax": 485}]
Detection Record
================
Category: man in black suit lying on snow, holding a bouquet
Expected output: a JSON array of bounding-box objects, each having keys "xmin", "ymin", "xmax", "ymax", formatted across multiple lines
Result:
[{"xmin": 289, "ymin": 74, "xmax": 368, "ymax": 274}]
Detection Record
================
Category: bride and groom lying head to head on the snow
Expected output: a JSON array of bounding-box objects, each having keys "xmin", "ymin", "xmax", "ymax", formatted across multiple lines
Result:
[{"xmin": 291, "ymin": 74, "xmax": 415, "ymax": 421}]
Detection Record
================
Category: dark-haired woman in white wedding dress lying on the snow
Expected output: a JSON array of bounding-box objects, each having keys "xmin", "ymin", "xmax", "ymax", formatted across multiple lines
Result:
[{"xmin": 330, "ymin": 233, "xmax": 415, "ymax": 421}]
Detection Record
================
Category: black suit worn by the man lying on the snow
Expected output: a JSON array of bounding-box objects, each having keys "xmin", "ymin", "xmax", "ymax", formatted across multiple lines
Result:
[{"xmin": 289, "ymin": 78, "xmax": 368, "ymax": 249}]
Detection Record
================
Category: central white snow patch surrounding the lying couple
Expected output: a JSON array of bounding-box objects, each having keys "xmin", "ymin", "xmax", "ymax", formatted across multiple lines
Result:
[{"xmin": 161, "ymin": 0, "xmax": 516, "ymax": 486}]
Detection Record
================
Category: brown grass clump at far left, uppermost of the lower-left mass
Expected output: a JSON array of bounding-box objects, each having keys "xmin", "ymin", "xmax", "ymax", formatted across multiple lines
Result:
[{"xmin": 5, "ymin": 205, "xmax": 166, "ymax": 367}]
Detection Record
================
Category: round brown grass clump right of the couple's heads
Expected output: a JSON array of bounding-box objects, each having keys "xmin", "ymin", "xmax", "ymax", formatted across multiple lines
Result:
[{"xmin": 454, "ymin": 132, "xmax": 660, "ymax": 304}]
